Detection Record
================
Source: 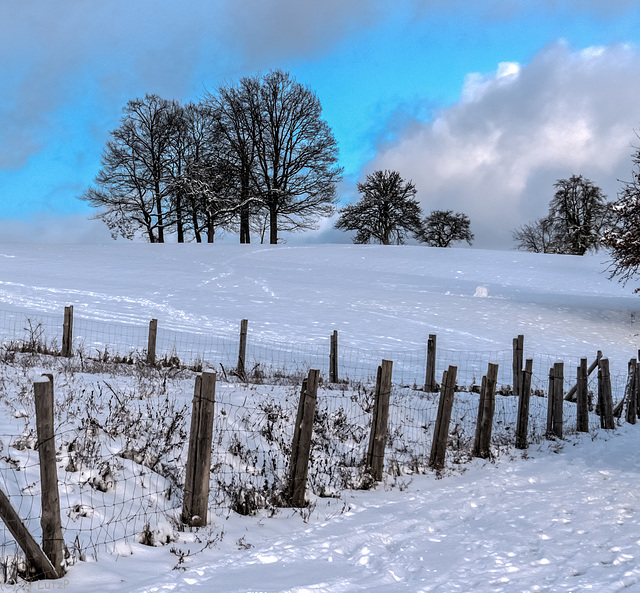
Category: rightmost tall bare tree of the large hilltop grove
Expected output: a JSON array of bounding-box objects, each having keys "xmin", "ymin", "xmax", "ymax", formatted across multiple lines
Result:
[{"xmin": 241, "ymin": 70, "xmax": 342, "ymax": 243}]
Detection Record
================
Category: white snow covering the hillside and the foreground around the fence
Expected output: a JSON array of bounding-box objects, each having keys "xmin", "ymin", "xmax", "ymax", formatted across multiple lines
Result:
[{"xmin": 0, "ymin": 244, "xmax": 640, "ymax": 592}]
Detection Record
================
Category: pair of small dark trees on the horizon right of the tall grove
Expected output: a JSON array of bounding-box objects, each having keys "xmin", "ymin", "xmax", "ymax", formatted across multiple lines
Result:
[{"xmin": 335, "ymin": 171, "xmax": 473, "ymax": 247}]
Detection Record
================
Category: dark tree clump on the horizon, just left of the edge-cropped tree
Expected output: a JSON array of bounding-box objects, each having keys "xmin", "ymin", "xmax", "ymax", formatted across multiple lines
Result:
[{"xmin": 513, "ymin": 175, "xmax": 610, "ymax": 255}]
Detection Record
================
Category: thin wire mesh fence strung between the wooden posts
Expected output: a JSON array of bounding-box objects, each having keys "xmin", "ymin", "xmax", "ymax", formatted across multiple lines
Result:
[{"xmin": 0, "ymin": 302, "xmax": 628, "ymax": 582}]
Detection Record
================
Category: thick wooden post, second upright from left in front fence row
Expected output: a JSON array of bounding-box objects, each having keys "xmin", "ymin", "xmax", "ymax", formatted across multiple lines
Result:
[{"xmin": 182, "ymin": 371, "xmax": 216, "ymax": 527}]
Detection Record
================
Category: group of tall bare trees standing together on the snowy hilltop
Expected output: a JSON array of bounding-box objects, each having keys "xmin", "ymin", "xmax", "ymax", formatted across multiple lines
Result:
[{"xmin": 81, "ymin": 70, "xmax": 342, "ymax": 243}]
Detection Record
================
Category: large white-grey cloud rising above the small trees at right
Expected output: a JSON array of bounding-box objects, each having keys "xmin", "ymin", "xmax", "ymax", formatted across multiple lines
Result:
[{"xmin": 367, "ymin": 43, "xmax": 640, "ymax": 247}]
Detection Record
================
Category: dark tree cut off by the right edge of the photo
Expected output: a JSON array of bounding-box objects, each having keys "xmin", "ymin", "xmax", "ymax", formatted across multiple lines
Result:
[{"xmin": 602, "ymin": 149, "xmax": 640, "ymax": 284}]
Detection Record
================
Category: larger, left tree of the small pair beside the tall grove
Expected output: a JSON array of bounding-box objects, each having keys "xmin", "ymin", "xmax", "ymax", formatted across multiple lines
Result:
[{"xmin": 335, "ymin": 171, "xmax": 422, "ymax": 245}]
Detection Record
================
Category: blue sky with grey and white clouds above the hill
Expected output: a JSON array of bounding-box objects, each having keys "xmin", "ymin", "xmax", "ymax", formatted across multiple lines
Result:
[{"xmin": 0, "ymin": 0, "xmax": 640, "ymax": 249}]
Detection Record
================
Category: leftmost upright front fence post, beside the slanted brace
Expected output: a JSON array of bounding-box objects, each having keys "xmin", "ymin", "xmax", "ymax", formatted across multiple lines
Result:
[{"xmin": 33, "ymin": 375, "xmax": 65, "ymax": 577}]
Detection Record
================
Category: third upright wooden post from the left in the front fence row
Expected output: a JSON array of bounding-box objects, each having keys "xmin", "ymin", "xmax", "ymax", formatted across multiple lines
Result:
[{"xmin": 287, "ymin": 369, "xmax": 320, "ymax": 507}]
